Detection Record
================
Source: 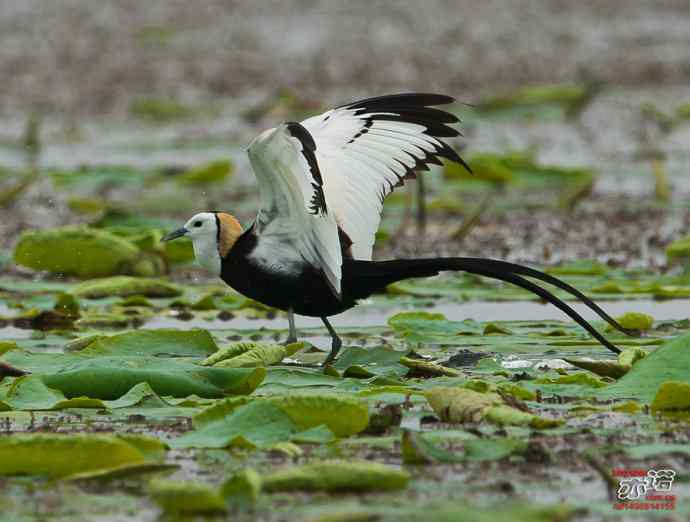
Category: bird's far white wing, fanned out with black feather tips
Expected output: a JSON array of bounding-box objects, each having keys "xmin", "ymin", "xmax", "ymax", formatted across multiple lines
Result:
[{"xmin": 301, "ymin": 93, "xmax": 469, "ymax": 259}]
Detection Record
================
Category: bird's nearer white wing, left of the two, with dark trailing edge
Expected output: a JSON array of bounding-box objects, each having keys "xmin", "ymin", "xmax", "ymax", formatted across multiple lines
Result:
[{"xmin": 248, "ymin": 119, "xmax": 342, "ymax": 297}]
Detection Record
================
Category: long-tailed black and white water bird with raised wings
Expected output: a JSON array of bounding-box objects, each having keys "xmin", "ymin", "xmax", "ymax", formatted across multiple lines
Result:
[{"xmin": 162, "ymin": 93, "xmax": 631, "ymax": 365}]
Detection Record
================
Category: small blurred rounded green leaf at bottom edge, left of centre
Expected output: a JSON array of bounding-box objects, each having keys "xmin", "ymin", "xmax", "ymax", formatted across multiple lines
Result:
[{"xmin": 149, "ymin": 479, "xmax": 225, "ymax": 514}]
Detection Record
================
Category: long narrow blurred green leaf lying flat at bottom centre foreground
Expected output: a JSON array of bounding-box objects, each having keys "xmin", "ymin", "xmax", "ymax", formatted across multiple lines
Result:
[{"xmin": 263, "ymin": 461, "xmax": 410, "ymax": 492}]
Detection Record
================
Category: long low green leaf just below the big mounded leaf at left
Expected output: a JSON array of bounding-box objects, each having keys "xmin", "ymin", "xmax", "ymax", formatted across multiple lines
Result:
[{"xmin": 72, "ymin": 276, "xmax": 182, "ymax": 299}]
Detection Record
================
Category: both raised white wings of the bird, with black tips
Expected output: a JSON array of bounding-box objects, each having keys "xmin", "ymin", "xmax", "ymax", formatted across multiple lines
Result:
[{"xmin": 249, "ymin": 93, "xmax": 469, "ymax": 288}]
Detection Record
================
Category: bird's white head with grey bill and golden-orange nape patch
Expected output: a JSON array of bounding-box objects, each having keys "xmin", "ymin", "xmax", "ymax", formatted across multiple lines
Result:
[{"xmin": 161, "ymin": 212, "xmax": 242, "ymax": 276}]
